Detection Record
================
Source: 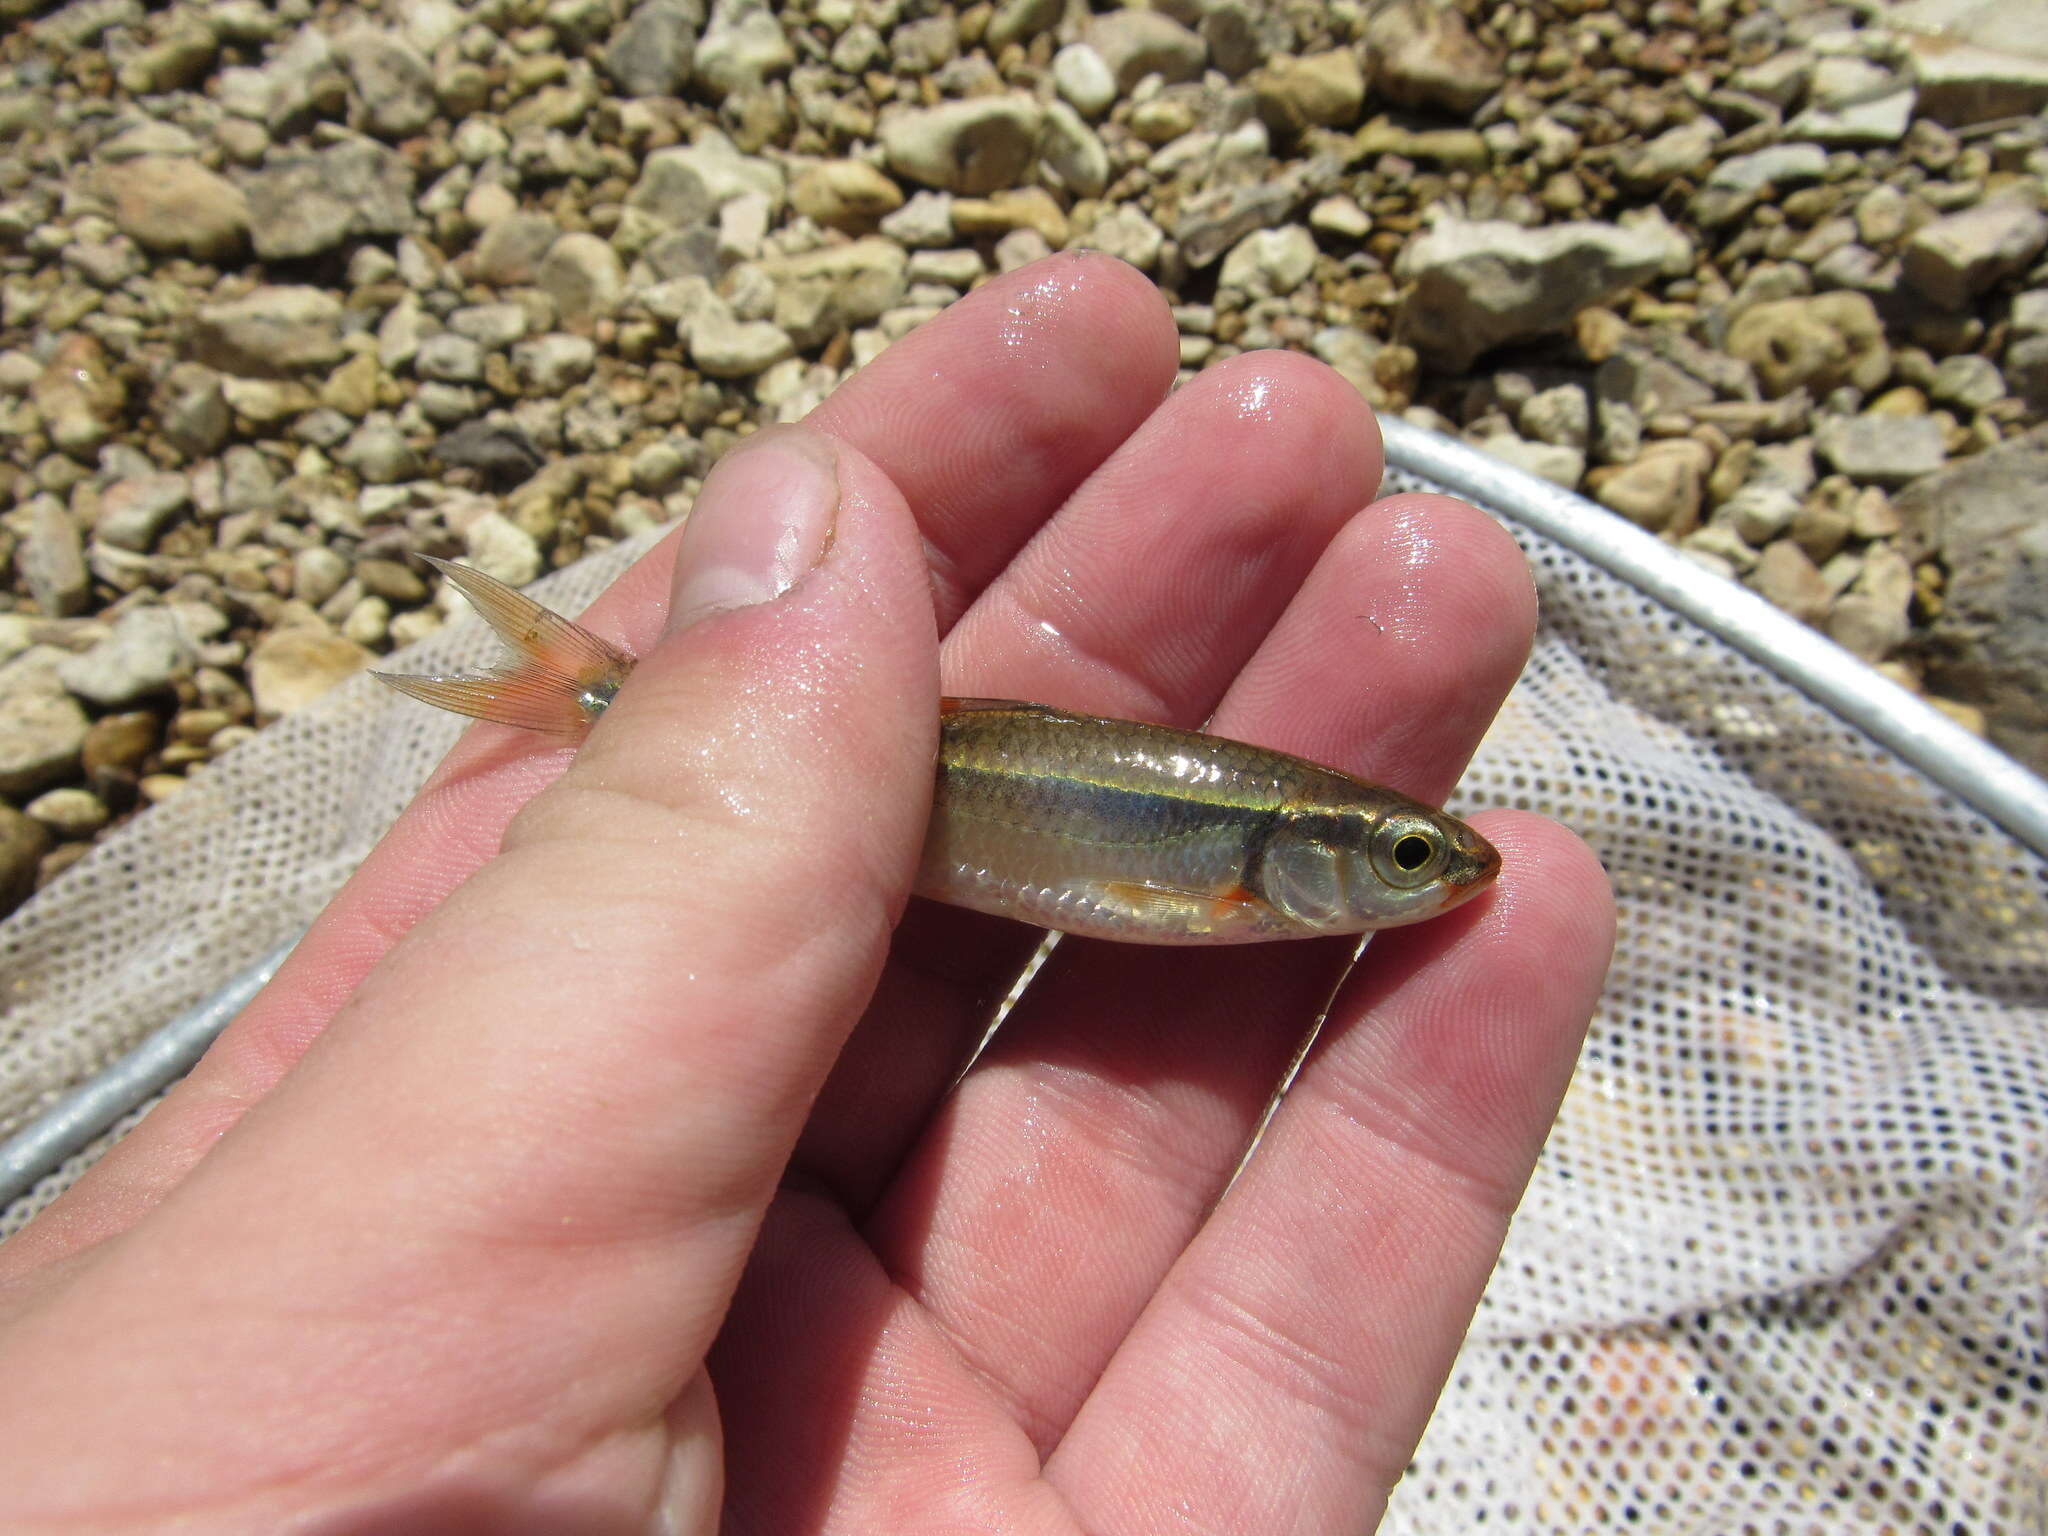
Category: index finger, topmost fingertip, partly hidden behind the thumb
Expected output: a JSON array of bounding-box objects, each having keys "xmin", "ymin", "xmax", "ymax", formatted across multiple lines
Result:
[{"xmin": 809, "ymin": 252, "xmax": 1180, "ymax": 633}]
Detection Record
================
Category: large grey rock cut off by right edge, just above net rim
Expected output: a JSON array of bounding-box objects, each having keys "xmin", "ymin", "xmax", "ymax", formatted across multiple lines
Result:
[{"xmin": 1894, "ymin": 430, "xmax": 2048, "ymax": 774}]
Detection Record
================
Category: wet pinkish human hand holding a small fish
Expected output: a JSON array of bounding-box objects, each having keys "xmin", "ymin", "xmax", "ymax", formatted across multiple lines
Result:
[{"xmin": 0, "ymin": 256, "xmax": 1612, "ymax": 1536}]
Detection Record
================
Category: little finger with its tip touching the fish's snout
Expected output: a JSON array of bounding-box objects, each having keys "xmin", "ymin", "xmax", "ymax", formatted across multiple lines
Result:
[{"xmin": 1047, "ymin": 813, "xmax": 1614, "ymax": 1534}]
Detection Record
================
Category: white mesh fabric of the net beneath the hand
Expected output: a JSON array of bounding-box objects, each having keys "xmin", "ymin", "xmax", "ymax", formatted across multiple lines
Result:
[{"xmin": 0, "ymin": 475, "xmax": 2048, "ymax": 1536}]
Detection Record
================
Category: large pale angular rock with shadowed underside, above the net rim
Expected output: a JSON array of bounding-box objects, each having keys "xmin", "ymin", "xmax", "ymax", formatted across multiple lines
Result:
[{"xmin": 1397, "ymin": 219, "xmax": 1665, "ymax": 371}]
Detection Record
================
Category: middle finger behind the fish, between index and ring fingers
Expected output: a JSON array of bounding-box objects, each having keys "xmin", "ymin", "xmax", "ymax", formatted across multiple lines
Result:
[{"xmin": 799, "ymin": 352, "xmax": 1382, "ymax": 1210}]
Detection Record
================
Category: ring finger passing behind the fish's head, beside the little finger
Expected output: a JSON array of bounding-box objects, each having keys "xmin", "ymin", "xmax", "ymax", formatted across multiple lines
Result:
[{"xmin": 868, "ymin": 498, "xmax": 1534, "ymax": 1448}]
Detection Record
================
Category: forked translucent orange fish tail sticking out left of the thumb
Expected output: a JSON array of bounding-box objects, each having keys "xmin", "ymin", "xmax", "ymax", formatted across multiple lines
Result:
[{"xmin": 373, "ymin": 555, "xmax": 633, "ymax": 735}]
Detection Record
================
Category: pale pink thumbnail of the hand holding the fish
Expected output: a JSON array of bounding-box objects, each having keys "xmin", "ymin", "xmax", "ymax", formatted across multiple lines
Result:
[{"xmin": 668, "ymin": 426, "xmax": 840, "ymax": 631}]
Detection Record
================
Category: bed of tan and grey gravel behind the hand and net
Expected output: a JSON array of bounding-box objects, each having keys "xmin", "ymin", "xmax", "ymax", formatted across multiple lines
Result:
[{"xmin": 0, "ymin": 0, "xmax": 2048, "ymax": 909}]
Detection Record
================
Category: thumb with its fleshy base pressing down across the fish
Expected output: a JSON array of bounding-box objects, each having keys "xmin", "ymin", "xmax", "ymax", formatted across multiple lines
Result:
[{"xmin": 0, "ymin": 428, "xmax": 938, "ymax": 1515}]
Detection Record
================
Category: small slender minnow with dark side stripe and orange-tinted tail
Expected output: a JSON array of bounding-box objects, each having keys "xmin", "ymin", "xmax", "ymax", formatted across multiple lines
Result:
[{"xmin": 375, "ymin": 557, "xmax": 1501, "ymax": 944}]
